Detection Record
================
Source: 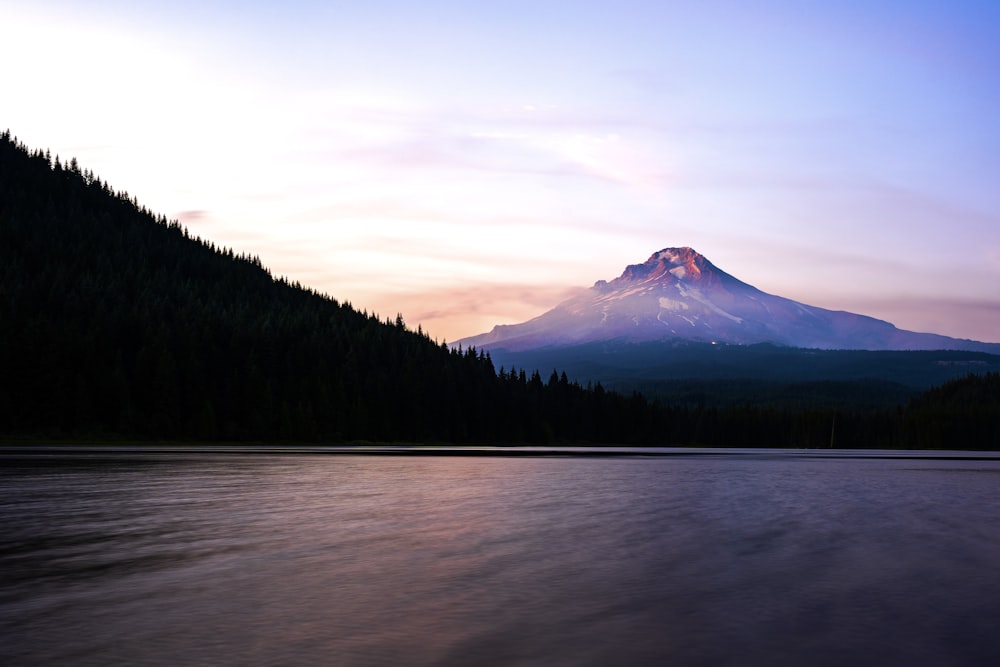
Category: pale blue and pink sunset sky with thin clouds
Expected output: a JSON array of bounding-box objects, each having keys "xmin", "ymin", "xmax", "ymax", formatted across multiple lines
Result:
[{"xmin": 0, "ymin": 0, "xmax": 1000, "ymax": 342}]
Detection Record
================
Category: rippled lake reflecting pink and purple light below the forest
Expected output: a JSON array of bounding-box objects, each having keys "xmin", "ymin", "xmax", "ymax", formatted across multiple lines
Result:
[{"xmin": 0, "ymin": 448, "xmax": 1000, "ymax": 666}]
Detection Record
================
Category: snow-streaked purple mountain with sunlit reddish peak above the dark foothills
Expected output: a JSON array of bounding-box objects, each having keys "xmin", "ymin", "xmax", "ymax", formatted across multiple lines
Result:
[{"xmin": 458, "ymin": 247, "xmax": 1000, "ymax": 353}]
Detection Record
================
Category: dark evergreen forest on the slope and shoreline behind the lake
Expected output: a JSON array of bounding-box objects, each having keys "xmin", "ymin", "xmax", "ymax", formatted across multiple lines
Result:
[{"xmin": 0, "ymin": 131, "xmax": 1000, "ymax": 449}]
